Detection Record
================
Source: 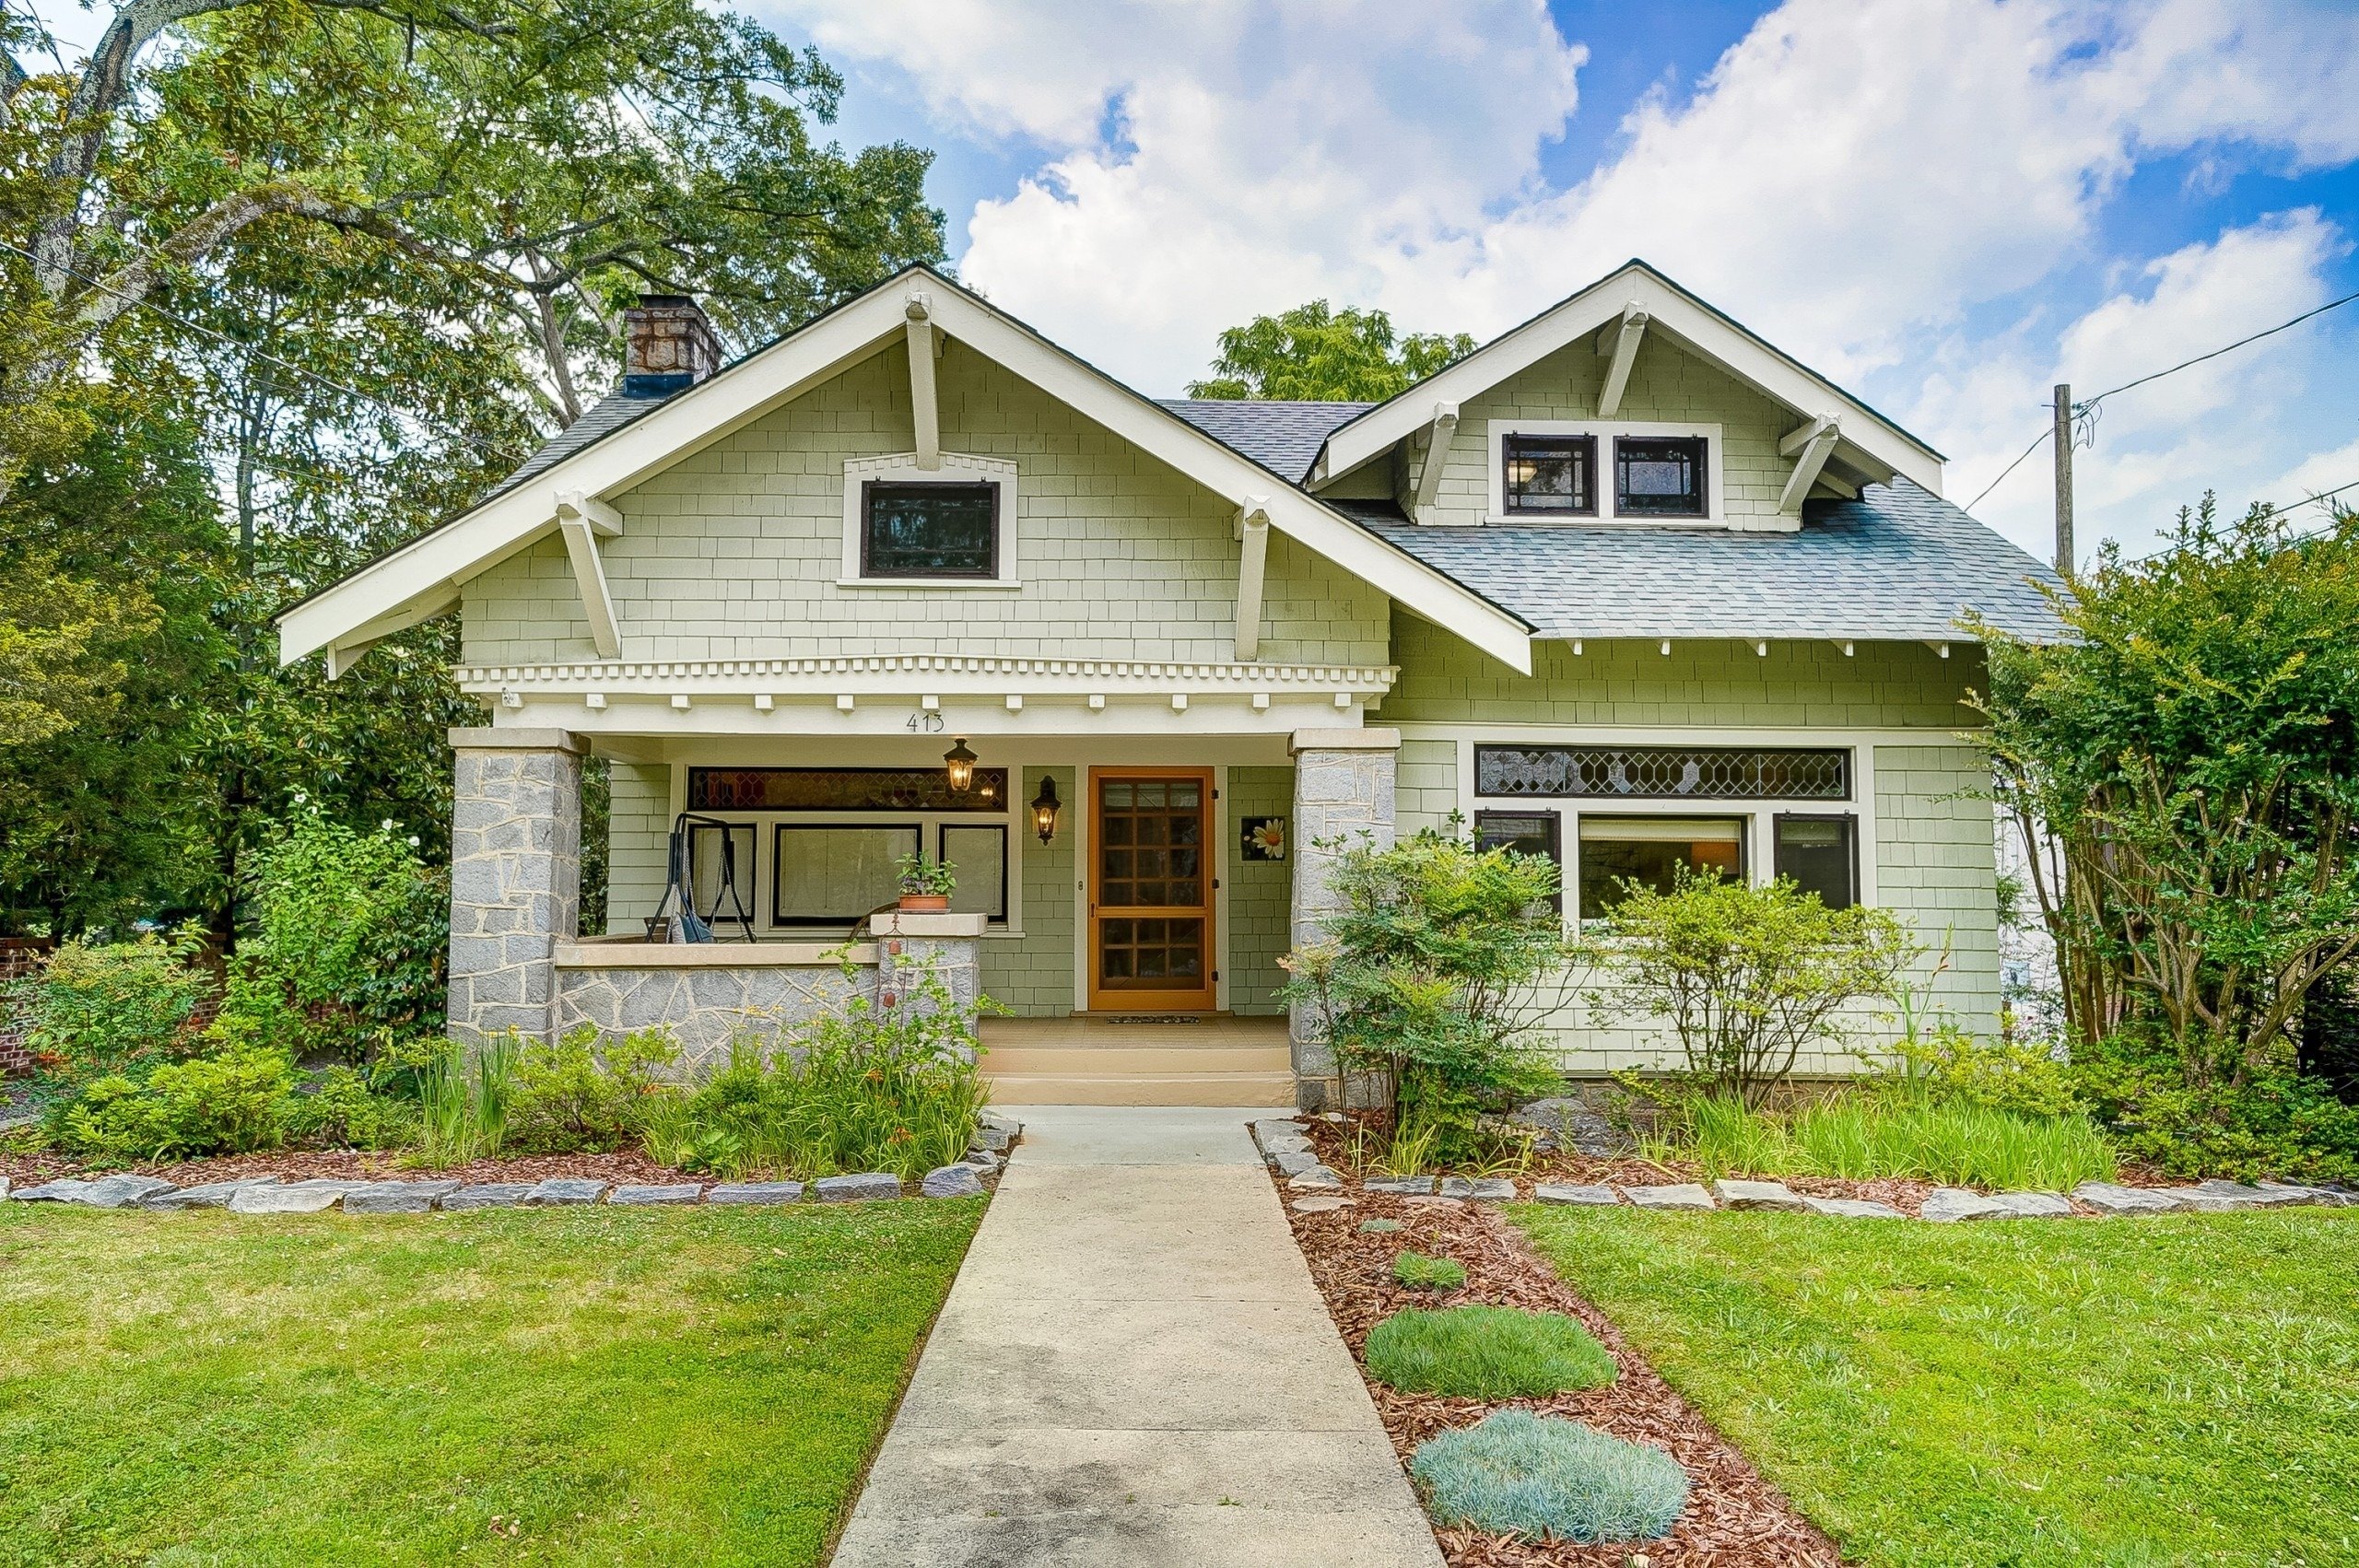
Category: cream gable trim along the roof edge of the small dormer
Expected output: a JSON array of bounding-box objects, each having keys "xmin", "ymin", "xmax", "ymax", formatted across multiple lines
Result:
[{"xmin": 1309, "ymin": 260, "xmax": 1942, "ymax": 495}]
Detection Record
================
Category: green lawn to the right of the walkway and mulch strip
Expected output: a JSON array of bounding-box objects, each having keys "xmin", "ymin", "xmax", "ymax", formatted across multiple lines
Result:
[{"xmin": 1515, "ymin": 1207, "xmax": 2359, "ymax": 1568}]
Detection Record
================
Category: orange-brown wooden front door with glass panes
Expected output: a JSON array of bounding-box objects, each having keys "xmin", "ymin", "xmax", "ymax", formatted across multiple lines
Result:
[{"xmin": 1090, "ymin": 768, "xmax": 1217, "ymax": 1012}]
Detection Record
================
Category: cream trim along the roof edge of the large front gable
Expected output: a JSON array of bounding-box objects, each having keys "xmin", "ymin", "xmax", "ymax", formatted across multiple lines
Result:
[{"xmin": 278, "ymin": 266, "xmax": 1531, "ymax": 670}]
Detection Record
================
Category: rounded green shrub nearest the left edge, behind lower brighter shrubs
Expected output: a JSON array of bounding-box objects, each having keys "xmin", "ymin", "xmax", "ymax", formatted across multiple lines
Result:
[{"xmin": 26, "ymin": 931, "xmax": 212, "ymax": 1084}]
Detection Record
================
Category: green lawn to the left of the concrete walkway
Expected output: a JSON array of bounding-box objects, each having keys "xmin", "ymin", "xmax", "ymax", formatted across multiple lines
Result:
[{"xmin": 0, "ymin": 1200, "xmax": 981, "ymax": 1568}]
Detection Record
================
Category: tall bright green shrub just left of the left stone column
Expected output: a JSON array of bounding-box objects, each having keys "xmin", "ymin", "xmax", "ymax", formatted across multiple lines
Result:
[{"xmin": 241, "ymin": 813, "xmax": 451, "ymax": 1054}]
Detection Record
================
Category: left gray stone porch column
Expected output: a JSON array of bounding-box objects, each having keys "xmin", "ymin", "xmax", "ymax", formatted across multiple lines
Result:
[{"xmin": 451, "ymin": 729, "xmax": 590, "ymax": 1045}]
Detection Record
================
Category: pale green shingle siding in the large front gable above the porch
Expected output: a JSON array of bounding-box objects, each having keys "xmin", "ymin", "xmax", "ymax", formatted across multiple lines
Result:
[{"xmin": 464, "ymin": 345, "xmax": 1387, "ymax": 665}]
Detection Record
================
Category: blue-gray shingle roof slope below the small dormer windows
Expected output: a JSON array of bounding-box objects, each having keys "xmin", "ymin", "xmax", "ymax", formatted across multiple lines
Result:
[{"xmin": 1331, "ymin": 479, "xmax": 2061, "ymax": 641}]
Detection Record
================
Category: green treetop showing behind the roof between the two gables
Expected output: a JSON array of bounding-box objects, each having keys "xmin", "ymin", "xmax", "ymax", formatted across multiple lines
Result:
[{"xmin": 1187, "ymin": 299, "xmax": 1474, "ymax": 404}]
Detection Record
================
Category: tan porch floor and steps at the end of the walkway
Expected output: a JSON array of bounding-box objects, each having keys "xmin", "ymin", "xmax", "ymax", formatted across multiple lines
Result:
[{"xmin": 981, "ymin": 1014, "xmax": 1295, "ymax": 1106}]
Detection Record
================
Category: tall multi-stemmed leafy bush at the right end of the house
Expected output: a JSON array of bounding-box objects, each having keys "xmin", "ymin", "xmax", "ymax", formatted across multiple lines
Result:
[{"xmin": 1981, "ymin": 497, "xmax": 2359, "ymax": 1087}]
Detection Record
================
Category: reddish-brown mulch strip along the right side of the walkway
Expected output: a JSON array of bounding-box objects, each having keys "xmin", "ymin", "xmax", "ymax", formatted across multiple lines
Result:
[{"xmin": 1281, "ymin": 1175, "xmax": 1839, "ymax": 1568}]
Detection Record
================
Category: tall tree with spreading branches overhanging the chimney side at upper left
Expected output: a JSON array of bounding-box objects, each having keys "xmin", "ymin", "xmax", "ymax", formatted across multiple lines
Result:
[{"xmin": 0, "ymin": 0, "xmax": 941, "ymax": 486}]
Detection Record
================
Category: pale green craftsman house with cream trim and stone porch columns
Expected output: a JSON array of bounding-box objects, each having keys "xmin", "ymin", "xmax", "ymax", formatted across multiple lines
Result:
[{"xmin": 281, "ymin": 262, "xmax": 2052, "ymax": 1106}]
